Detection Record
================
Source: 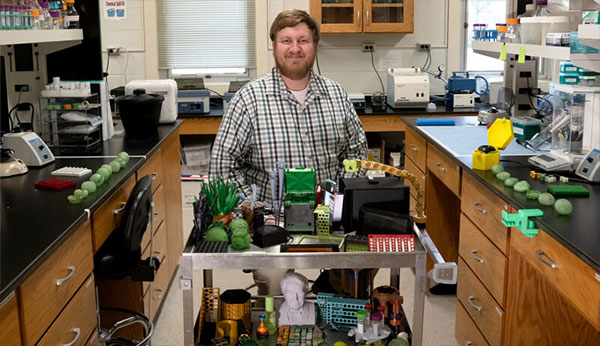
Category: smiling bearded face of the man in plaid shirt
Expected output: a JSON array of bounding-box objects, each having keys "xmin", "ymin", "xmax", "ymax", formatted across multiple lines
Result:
[{"xmin": 273, "ymin": 23, "xmax": 316, "ymax": 80}]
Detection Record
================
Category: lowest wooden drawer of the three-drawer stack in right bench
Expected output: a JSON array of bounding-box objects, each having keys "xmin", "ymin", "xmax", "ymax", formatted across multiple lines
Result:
[{"xmin": 456, "ymin": 258, "xmax": 504, "ymax": 345}]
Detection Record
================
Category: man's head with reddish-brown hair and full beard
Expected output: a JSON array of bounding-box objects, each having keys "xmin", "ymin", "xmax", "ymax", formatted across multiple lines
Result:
[{"xmin": 270, "ymin": 10, "xmax": 320, "ymax": 80}]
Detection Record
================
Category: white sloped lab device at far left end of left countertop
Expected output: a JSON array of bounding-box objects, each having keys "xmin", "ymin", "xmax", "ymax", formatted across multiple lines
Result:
[{"xmin": 2, "ymin": 132, "xmax": 54, "ymax": 167}]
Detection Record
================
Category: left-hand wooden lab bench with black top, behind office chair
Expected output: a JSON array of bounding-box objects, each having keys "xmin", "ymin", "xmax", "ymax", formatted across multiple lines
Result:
[{"xmin": 0, "ymin": 121, "xmax": 183, "ymax": 345}]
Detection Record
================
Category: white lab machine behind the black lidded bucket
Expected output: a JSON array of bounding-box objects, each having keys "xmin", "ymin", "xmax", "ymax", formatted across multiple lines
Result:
[{"xmin": 125, "ymin": 79, "xmax": 177, "ymax": 124}]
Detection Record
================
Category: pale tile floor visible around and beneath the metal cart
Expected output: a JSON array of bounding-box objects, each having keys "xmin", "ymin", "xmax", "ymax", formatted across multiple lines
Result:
[{"xmin": 152, "ymin": 182, "xmax": 457, "ymax": 346}]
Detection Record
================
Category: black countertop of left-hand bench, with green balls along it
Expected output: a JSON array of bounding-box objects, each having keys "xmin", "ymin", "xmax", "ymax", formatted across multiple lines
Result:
[{"xmin": 0, "ymin": 121, "xmax": 182, "ymax": 300}]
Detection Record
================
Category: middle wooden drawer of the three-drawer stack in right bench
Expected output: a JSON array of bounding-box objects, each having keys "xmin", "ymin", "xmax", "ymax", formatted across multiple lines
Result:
[{"xmin": 458, "ymin": 214, "xmax": 508, "ymax": 308}]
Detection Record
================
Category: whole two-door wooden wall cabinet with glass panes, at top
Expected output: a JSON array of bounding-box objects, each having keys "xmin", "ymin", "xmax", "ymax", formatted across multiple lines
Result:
[{"xmin": 310, "ymin": 0, "xmax": 414, "ymax": 34}]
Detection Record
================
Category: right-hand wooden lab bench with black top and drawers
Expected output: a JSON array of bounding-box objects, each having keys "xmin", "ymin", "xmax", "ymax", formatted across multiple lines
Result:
[{"xmin": 402, "ymin": 117, "xmax": 600, "ymax": 345}]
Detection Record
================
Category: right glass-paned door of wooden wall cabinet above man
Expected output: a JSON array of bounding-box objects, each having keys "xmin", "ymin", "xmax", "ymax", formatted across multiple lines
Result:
[{"xmin": 363, "ymin": 0, "xmax": 414, "ymax": 33}]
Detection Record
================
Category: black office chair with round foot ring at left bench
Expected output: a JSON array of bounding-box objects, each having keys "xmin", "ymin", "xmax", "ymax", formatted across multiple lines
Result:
[{"xmin": 94, "ymin": 175, "xmax": 159, "ymax": 345}]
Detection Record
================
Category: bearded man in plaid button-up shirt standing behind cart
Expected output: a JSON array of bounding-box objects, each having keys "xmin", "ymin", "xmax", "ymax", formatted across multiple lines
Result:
[{"xmin": 210, "ymin": 10, "xmax": 367, "ymax": 202}]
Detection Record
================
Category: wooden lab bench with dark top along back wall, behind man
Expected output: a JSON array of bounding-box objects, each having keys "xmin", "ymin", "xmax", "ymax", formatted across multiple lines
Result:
[{"xmin": 178, "ymin": 100, "xmax": 488, "ymax": 135}]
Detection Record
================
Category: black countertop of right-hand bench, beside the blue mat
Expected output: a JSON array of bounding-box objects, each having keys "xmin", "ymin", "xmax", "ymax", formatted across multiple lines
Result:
[{"xmin": 402, "ymin": 117, "xmax": 600, "ymax": 271}]
